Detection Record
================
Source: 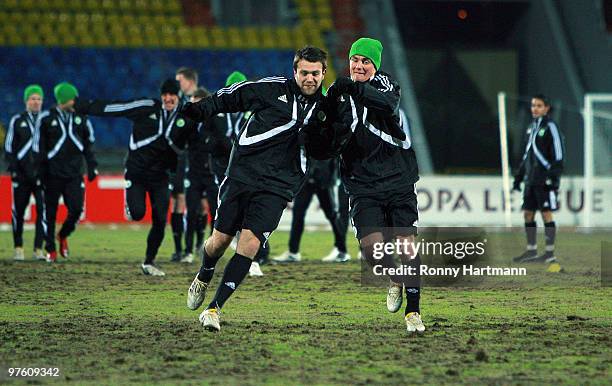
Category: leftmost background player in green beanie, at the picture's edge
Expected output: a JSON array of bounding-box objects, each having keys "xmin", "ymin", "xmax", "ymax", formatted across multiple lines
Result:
[{"xmin": 4, "ymin": 84, "xmax": 45, "ymax": 260}]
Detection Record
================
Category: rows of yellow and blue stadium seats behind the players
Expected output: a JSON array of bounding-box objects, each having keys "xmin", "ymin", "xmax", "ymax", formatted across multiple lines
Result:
[{"xmin": 0, "ymin": 0, "xmax": 336, "ymax": 148}]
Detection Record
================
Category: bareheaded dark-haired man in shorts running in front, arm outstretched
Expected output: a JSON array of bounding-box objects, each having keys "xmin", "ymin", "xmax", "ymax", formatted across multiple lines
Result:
[{"xmin": 184, "ymin": 47, "xmax": 327, "ymax": 330}]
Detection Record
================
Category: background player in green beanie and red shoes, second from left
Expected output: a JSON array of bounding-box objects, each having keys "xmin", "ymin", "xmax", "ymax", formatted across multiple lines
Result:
[{"xmin": 34, "ymin": 82, "xmax": 98, "ymax": 261}]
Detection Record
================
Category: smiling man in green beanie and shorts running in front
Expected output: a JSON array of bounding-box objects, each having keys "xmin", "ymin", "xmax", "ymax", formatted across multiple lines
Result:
[{"xmin": 319, "ymin": 37, "xmax": 425, "ymax": 333}]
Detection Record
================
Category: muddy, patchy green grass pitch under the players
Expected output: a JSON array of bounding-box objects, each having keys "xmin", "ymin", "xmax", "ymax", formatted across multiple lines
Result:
[{"xmin": 0, "ymin": 226, "xmax": 612, "ymax": 385}]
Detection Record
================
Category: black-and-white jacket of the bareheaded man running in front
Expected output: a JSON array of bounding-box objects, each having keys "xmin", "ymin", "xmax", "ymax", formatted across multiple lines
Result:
[{"xmin": 185, "ymin": 77, "xmax": 322, "ymax": 201}]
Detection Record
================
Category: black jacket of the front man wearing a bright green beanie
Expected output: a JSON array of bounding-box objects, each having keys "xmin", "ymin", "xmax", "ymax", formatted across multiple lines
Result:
[{"xmin": 307, "ymin": 71, "xmax": 419, "ymax": 196}]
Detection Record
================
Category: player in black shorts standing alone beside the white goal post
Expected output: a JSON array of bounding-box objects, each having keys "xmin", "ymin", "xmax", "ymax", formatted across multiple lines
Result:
[{"xmin": 513, "ymin": 95, "xmax": 564, "ymax": 263}]
